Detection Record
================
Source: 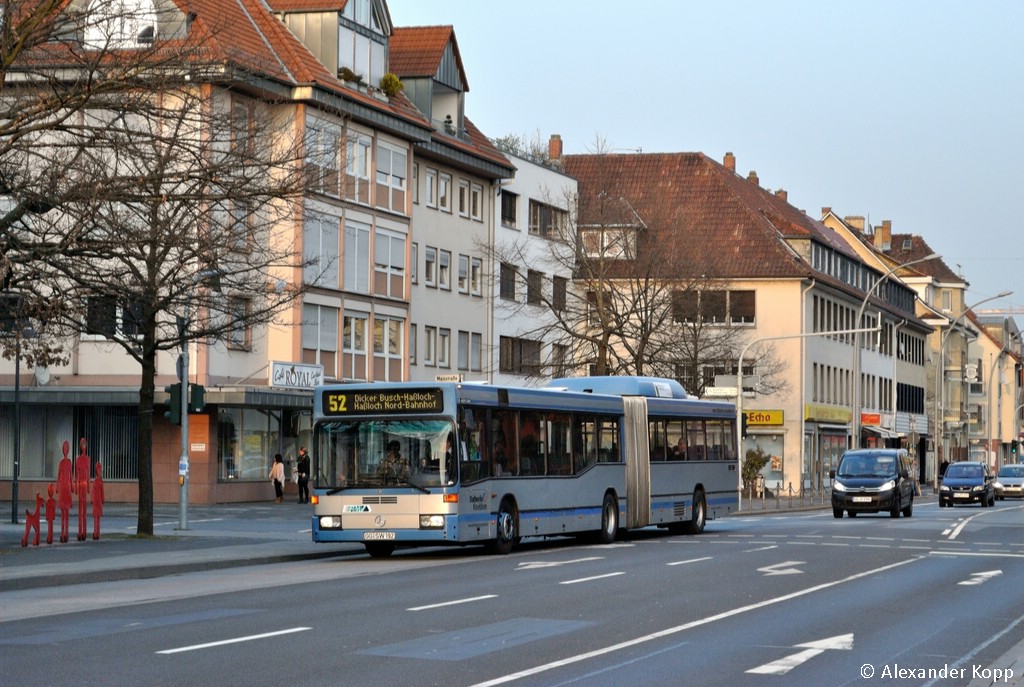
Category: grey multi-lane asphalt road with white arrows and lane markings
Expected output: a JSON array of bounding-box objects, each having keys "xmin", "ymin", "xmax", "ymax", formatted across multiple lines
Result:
[{"xmin": 0, "ymin": 502, "xmax": 1024, "ymax": 687}]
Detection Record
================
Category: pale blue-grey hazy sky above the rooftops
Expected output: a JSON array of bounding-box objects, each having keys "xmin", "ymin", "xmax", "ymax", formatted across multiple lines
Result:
[{"xmin": 388, "ymin": 0, "xmax": 1024, "ymax": 311}]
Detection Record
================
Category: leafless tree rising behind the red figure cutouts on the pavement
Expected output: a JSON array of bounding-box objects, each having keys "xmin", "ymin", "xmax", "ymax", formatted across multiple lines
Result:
[{"xmin": 0, "ymin": 0, "xmax": 304, "ymax": 534}]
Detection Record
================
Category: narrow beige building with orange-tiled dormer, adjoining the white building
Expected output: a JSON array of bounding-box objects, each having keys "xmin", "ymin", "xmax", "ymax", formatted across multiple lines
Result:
[{"xmin": 391, "ymin": 27, "xmax": 514, "ymax": 387}]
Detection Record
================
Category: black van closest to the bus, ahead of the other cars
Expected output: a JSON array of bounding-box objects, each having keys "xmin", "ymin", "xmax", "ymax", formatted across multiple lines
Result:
[{"xmin": 828, "ymin": 448, "xmax": 916, "ymax": 518}]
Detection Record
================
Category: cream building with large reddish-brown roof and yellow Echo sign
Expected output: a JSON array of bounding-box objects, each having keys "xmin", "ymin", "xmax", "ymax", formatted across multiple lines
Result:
[{"xmin": 564, "ymin": 154, "xmax": 931, "ymax": 495}]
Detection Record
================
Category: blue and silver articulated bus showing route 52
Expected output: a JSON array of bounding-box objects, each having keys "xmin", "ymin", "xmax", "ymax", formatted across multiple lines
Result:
[{"xmin": 311, "ymin": 377, "xmax": 738, "ymax": 556}]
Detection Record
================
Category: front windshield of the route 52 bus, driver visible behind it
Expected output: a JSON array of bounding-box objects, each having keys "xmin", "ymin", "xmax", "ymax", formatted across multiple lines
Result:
[{"xmin": 313, "ymin": 419, "xmax": 458, "ymax": 489}]
